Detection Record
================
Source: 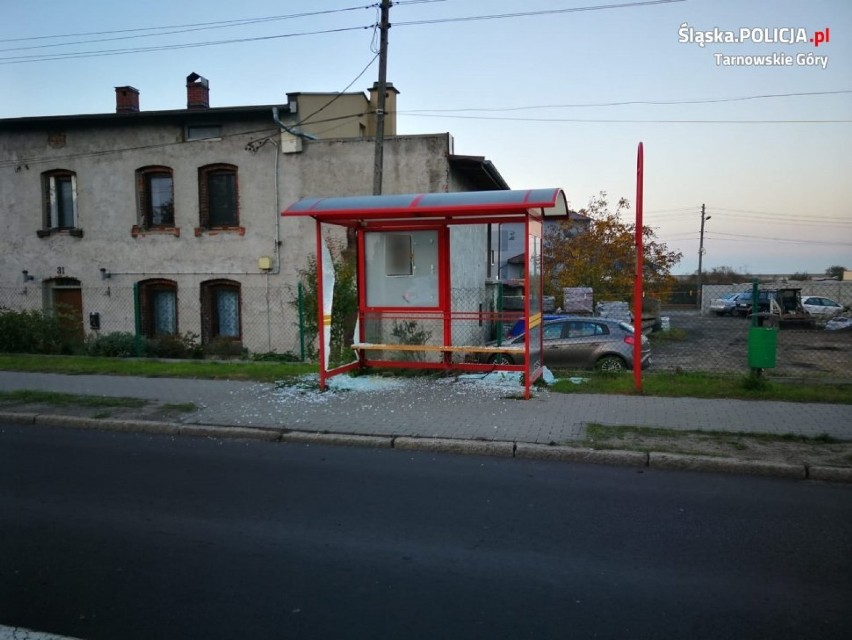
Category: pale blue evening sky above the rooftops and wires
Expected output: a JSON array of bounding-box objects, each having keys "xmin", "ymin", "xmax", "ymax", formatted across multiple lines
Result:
[{"xmin": 0, "ymin": 0, "xmax": 852, "ymax": 275}]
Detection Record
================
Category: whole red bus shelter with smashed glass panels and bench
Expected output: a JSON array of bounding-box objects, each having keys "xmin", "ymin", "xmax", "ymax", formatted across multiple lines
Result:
[{"xmin": 281, "ymin": 188, "xmax": 568, "ymax": 398}]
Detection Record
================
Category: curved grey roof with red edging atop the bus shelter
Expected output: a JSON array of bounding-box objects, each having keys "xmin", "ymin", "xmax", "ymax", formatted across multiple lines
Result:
[{"xmin": 281, "ymin": 188, "xmax": 568, "ymax": 225}]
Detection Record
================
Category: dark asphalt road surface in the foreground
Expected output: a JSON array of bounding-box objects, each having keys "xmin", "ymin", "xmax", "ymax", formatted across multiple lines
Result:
[{"xmin": 5, "ymin": 425, "xmax": 852, "ymax": 640}]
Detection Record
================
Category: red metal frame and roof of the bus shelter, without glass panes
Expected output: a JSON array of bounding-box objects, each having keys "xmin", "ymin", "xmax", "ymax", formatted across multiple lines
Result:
[{"xmin": 281, "ymin": 188, "xmax": 568, "ymax": 398}]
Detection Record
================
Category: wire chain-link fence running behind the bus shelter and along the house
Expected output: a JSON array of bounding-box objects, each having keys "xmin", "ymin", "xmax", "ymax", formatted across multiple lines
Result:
[{"xmin": 0, "ymin": 281, "xmax": 852, "ymax": 382}]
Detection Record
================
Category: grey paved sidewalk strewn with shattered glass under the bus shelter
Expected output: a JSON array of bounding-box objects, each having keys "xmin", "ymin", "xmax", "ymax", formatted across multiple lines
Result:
[{"xmin": 0, "ymin": 371, "xmax": 852, "ymax": 445}]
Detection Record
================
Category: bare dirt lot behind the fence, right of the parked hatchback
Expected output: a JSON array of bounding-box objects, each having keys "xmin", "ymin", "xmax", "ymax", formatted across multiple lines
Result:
[{"xmin": 652, "ymin": 311, "xmax": 852, "ymax": 380}]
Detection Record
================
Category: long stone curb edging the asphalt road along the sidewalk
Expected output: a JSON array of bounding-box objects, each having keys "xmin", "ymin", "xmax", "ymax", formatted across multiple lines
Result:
[{"xmin": 0, "ymin": 412, "xmax": 852, "ymax": 484}]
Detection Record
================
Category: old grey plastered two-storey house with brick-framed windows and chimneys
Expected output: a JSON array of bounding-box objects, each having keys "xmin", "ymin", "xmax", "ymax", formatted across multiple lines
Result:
[{"xmin": 0, "ymin": 73, "xmax": 508, "ymax": 353}]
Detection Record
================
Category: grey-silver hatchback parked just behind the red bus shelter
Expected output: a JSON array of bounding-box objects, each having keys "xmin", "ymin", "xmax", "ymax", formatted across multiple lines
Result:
[{"xmin": 482, "ymin": 316, "xmax": 651, "ymax": 371}]
